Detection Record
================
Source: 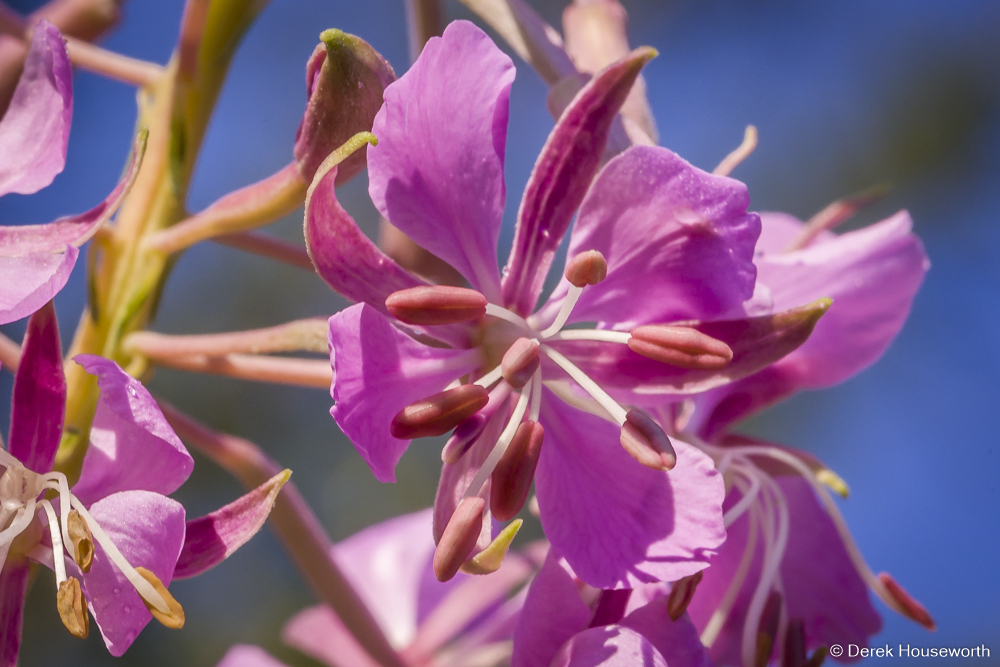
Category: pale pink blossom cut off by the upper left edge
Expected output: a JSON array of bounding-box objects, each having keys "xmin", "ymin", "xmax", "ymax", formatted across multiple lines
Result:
[{"xmin": 0, "ymin": 21, "xmax": 145, "ymax": 324}]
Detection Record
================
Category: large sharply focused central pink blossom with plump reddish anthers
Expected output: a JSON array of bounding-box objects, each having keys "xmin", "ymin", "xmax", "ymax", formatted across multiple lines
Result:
[{"xmin": 305, "ymin": 22, "xmax": 826, "ymax": 588}]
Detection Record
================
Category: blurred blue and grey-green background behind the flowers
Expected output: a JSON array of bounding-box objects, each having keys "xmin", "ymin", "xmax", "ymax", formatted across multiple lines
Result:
[{"xmin": 0, "ymin": 0, "xmax": 1000, "ymax": 666}]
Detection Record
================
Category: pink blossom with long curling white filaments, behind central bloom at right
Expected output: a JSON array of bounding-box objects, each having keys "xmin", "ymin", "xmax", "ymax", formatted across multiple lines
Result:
[{"xmin": 658, "ymin": 212, "xmax": 934, "ymax": 667}]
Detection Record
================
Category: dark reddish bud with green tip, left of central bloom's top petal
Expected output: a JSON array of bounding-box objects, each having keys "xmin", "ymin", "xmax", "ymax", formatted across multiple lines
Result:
[{"xmin": 294, "ymin": 30, "xmax": 396, "ymax": 185}]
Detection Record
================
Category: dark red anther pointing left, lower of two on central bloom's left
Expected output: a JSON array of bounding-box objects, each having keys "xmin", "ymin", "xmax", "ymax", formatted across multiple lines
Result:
[{"xmin": 389, "ymin": 384, "xmax": 489, "ymax": 440}]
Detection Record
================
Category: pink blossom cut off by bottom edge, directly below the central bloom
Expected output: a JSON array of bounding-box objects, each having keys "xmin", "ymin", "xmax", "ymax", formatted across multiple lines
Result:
[{"xmin": 511, "ymin": 550, "xmax": 712, "ymax": 667}]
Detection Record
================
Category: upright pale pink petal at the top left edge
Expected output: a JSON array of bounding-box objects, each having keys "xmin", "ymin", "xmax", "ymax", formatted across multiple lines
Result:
[{"xmin": 0, "ymin": 21, "xmax": 73, "ymax": 195}]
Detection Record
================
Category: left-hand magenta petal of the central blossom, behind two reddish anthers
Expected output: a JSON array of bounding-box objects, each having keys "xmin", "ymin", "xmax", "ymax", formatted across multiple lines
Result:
[{"xmin": 330, "ymin": 304, "xmax": 480, "ymax": 482}]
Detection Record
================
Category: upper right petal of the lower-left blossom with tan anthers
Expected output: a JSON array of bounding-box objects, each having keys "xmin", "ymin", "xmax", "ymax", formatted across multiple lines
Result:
[{"xmin": 73, "ymin": 354, "xmax": 194, "ymax": 506}]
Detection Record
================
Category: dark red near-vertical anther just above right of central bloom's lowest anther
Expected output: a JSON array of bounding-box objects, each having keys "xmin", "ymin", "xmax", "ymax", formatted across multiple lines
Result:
[{"xmin": 490, "ymin": 421, "xmax": 545, "ymax": 521}]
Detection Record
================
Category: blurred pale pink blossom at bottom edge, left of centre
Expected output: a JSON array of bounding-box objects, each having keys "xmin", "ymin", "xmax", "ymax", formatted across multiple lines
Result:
[{"xmin": 219, "ymin": 510, "xmax": 545, "ymax": 667}]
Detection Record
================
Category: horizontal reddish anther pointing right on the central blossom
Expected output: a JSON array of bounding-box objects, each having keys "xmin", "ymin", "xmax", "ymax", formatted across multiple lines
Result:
[{"xmin": 628, "ymin": 324, "xmax": 733, "ymax": 371}]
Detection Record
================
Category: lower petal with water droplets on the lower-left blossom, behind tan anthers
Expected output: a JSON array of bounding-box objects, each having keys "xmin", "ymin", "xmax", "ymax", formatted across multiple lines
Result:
[{"xmin": 81, "ymin": 489, "xmax": 184, "ymax": 657}]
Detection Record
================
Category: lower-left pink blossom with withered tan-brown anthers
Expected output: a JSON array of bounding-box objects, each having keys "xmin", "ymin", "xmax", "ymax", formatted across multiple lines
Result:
[{"xmin": 0, "ymin": 302, "xmax": 287, "ymax": 666}]
